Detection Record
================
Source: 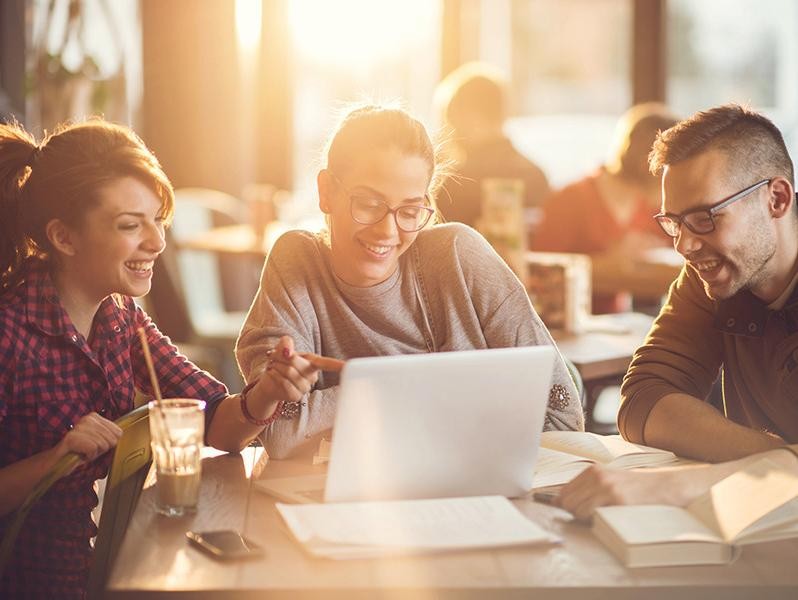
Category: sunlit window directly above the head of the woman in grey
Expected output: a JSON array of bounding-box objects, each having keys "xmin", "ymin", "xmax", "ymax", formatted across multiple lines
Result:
[{"xmin": 283, "ymin": 0, "xmax": 441, "ymax": 220}]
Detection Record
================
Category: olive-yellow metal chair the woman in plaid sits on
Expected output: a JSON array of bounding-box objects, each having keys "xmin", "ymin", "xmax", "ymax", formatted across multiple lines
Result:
[{"xmin": 0, "ymin": 404, "xmax": 152, "ymax": 598}]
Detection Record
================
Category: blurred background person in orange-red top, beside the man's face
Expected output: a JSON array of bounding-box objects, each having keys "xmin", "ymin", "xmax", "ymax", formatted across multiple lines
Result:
[{"xmin": 530, "ymin": 102, "xmax": 677, "ymax": 313}]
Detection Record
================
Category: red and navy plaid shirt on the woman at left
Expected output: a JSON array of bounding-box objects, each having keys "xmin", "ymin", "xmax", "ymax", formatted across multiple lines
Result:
[{"xmin": 0, "ymin": 260, "xmax": 227, "ymax": 598}]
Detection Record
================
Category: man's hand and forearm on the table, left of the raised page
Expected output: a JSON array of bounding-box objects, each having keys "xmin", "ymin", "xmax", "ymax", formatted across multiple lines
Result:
[{"xmin": 554, "ymin": 465, "xmax": 686, "ymax": 519}]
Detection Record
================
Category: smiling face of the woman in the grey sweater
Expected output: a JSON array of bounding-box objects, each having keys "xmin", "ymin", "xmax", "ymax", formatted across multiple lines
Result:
[{"xmin": 319, "ymin": 147, "xmax": 430, "ymax": 287}]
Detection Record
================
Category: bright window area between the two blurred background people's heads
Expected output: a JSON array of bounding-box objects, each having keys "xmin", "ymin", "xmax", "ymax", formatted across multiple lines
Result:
[{"xmin": 500, "ymin": 0, "xmax": 632, "ymax": 187}]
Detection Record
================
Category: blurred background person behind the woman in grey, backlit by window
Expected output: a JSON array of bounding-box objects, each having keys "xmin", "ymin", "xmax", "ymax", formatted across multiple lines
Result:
[{"xmin": 435, "ymin": 62, "xmax": 549, "ymax": 227}]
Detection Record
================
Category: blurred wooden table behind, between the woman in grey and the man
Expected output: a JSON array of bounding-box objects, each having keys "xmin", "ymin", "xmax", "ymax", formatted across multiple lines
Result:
[{"xmin": 552, "ymin": 313, "xmax": 654, "ymax": 433}]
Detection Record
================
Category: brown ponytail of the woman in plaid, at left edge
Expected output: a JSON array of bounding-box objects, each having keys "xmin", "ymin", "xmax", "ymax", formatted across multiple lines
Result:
[{"xmin": 0, "ymin": 122, "xmax": 39, "ymax": 293}]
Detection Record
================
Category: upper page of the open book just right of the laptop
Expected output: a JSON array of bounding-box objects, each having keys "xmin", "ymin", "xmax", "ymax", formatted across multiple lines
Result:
[{"xmin": 540, "ymin": 431, "xmax": 676, "ymax": 468}]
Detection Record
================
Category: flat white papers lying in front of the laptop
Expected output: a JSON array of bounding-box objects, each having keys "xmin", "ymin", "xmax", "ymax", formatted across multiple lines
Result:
[{"xmin": 276, "ymin": 496, "xmax": 559, "ymax": 559}]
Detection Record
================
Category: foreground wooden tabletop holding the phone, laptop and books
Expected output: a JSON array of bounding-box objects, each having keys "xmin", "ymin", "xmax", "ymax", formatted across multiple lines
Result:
[{"xmin": 108, "ymin": 450, "xmax": 798, "ymax": 600}]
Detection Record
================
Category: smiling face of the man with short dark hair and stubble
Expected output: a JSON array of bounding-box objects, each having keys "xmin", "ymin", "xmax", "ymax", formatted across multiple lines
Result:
[{"xmin": 662, "ymin": 149, "xmax": 777, "ymax": 300}]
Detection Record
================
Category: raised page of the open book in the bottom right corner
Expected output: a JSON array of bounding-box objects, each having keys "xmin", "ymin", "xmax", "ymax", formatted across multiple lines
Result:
[{"xmin": 687, "ymin": 458, "xmax": 798, "ymax": 542}]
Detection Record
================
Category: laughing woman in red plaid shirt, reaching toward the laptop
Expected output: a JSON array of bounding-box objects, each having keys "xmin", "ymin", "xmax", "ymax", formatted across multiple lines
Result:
[{"xmin": 0, "ymin": 120, "xmax": 318, "ymax": 599}]
